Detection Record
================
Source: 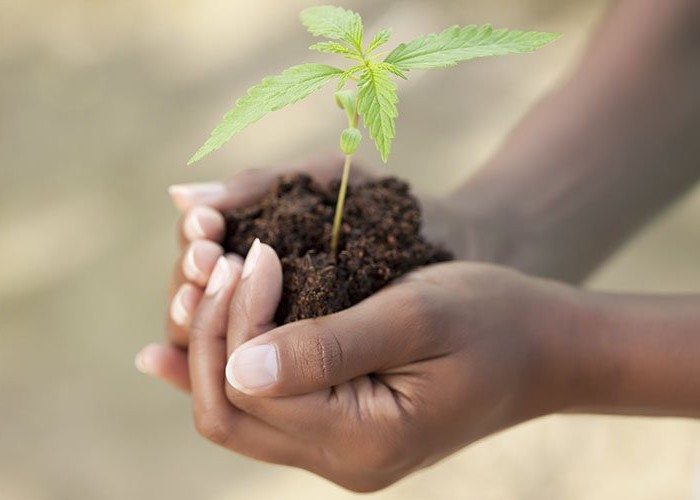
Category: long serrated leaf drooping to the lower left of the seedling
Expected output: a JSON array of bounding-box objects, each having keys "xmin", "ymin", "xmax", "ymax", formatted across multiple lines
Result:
[{"xmin": 187, "ymin": 64, "xmax": 343, "ymax": 165}]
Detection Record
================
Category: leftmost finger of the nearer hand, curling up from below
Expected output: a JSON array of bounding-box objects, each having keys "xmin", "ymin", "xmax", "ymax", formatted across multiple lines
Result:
[{"xmin": 189, "ymin": 254, "xmax": 318, "ymax": 465}]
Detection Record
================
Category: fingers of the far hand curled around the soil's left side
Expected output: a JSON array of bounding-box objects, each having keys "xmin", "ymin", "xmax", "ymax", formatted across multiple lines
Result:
[{"xmin": 136, "ymin": 155, "xmax": 350, "ymax": 391}]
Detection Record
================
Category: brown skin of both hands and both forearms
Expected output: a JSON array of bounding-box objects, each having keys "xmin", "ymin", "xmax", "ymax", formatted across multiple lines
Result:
[{"xmin": 138, "ymin": 0, "xmax": 700, "ymax": 491}]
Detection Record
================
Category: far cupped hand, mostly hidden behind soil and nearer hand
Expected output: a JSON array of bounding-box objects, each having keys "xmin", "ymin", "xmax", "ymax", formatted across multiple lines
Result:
[{"xmin": 137, "ymin": 155, "xmax": 498, "ymax": 391}]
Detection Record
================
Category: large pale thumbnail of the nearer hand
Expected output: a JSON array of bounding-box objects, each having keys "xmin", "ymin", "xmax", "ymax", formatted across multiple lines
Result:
[{"xmin": 226, "ymin": 344, "xmax": 278, "ymax": 391}]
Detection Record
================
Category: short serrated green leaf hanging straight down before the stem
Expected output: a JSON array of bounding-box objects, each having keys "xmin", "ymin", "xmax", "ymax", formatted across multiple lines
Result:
[{"xmin": 357, "ymin": 65, "xmax": 399, "ymax": 163}]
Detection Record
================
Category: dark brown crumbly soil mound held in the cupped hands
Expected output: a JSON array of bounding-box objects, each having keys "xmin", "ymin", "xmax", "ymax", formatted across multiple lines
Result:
[{"xmin": 224, "ymin": 175, "xmax": 452, "ymax": 324}]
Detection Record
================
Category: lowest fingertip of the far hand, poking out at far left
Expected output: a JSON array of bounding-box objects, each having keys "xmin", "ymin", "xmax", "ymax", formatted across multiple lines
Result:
[{"xmin": 135, "ymin": 344, "xmax": 190, "ymax": 392}]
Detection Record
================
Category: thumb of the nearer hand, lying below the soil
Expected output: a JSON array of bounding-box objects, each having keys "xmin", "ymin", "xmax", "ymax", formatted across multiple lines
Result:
[{"xmin": 226, "ymin": 282, "xmax": 449, "ymax": 397}]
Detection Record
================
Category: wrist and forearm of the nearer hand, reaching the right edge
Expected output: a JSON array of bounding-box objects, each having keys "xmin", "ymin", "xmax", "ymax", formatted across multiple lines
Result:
[{"xmin": 548, "ymin": 292, "xmax": 700, "ymax": 417}]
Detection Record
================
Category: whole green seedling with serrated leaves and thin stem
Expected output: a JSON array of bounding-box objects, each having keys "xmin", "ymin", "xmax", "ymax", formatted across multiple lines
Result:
[{"xmin": 189, "ymin": 6, "xmax": 560, "ymax": 254}]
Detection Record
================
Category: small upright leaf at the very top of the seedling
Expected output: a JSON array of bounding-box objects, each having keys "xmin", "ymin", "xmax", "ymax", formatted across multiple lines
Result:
[{"xmin": 300, "ymin": 5, "xmax": 362, "ymax": 50}]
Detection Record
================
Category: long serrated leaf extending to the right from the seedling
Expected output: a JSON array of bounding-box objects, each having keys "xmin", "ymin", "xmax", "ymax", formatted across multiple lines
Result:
[{"xmin": 384, "ymin": 25, "xmax": 561, "ymax": 71}]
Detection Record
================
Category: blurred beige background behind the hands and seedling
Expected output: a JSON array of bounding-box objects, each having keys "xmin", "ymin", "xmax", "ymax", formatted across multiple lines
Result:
[{"xmin": 0, "ymin": 0, "xmax": 700, "ymax": 500}]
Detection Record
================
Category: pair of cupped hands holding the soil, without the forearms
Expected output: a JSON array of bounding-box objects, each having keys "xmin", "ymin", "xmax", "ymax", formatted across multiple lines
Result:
[{"xmin": 137, "ymin": 156, "xmax": 572, "ymax": 491}]
